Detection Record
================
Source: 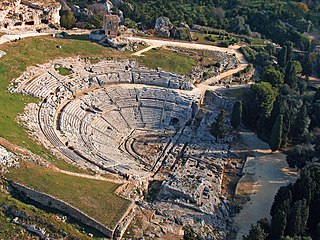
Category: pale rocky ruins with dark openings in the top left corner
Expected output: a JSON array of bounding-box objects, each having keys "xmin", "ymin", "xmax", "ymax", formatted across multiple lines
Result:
[{"xmin": 0, "ymin": 0, "xmax": 61, "ymax": 29}]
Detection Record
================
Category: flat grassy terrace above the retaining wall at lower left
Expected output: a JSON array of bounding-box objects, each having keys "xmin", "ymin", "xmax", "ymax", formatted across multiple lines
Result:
[{"xmin": 6, "ymin": 165, "xmax": 130, "ymax": 227}]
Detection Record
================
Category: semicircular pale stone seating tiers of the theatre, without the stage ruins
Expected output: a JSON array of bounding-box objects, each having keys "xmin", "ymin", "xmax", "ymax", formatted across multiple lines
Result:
[{"xmin": 13, "ymin": 59, "xmax": 198, "ymax": 175}]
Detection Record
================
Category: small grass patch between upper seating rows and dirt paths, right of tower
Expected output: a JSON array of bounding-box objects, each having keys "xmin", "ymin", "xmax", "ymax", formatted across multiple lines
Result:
[{"xmin": 137, "ymin": 48, "xmax": 197, "ymax": 75}]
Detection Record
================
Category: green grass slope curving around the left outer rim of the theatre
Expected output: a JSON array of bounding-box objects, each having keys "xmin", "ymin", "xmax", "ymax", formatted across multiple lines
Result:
[{"xmin": 0, "ymin": 36, "xmax": 128, "ymax": 171}]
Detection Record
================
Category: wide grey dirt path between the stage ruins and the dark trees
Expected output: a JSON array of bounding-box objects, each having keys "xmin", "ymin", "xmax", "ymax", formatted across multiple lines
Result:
[{"xmin": 234, "ymin": 132, "xmax": 298, "ymax": 240}]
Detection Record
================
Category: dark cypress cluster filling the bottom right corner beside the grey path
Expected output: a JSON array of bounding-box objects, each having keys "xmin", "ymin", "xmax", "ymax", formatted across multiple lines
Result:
[{"xmin": 244, "ymin": 163, "xmax": 320, "ymax": 240}]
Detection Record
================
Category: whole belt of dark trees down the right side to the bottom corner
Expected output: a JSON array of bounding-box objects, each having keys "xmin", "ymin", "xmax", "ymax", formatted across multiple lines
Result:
[{"xmin": 235, "ymin": 17, "xmax": 320, "ymax": 240}]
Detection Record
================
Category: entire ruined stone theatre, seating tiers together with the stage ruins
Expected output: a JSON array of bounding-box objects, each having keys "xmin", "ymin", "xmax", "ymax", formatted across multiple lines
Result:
[{"xmin": 10, "ymin": 59, "xmax": 232, "ymax": 238}]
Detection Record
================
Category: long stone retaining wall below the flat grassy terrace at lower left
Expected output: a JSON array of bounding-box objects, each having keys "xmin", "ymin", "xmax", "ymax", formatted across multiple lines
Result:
[{"xmin": 8, "ymin": 181, "xmax": 114, "ymax": 238}]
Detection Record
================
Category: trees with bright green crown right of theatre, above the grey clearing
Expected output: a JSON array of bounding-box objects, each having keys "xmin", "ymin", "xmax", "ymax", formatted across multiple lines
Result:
[{"xmin": 242, "ymin": 40, "xmax": 320, "ymax": 168}]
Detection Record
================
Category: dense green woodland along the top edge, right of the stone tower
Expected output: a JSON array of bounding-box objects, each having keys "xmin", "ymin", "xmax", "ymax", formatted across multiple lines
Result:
[{"xmin": 120, "ymin": 0, "xmax": 319, "ymax": 50}]
